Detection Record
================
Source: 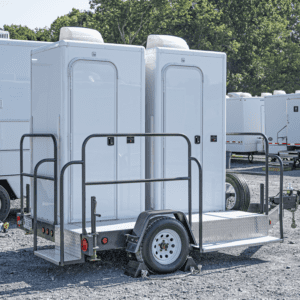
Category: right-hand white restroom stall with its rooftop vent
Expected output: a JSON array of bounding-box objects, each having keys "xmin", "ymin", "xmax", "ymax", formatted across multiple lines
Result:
[{"xmin": 146, "ymin": 35, "xmax": 226, "ymax": 212}]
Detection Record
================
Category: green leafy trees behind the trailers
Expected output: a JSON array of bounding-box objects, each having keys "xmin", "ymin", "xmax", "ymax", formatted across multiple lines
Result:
[{"xmin": 3, "ymin": 0, "xmax": 300, "ymax": 95}]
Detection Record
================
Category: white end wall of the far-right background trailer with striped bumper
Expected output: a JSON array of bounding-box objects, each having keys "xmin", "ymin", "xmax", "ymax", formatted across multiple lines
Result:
[{"xmin": 265, "ymin": 90, "xmax": 288, "ymax": 154}]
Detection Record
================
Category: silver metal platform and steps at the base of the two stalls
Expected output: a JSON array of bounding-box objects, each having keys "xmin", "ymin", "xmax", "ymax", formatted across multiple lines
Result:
[{"xmin": 34, "ymin": 211, "xmax": 282, "ymax": 265}]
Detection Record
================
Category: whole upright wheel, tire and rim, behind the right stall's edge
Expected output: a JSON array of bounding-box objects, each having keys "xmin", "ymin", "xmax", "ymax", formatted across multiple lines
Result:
[{"xmin": 225, "ymin": 173, "xmax": 250, "ymax": 211}]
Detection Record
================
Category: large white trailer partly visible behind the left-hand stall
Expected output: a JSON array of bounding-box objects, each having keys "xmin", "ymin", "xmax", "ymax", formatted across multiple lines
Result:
[{"xmin": 0, "ymin": 37, "xmax": 51, "ymax": 221}]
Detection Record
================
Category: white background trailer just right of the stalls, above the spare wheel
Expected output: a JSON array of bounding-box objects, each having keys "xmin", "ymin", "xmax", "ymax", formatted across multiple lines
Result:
[{"xmin": 226, "ymin": 92, "xmax": 265, "ymax": 154}]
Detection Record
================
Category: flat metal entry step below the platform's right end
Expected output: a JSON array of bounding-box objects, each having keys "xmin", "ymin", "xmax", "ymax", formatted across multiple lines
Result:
[{"xmin": 194, "ymin": 236, "xmax": 283, "ymax": 253}]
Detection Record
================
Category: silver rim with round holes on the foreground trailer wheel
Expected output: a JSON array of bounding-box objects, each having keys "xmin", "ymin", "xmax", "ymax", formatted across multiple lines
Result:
[{"xmin": 151, "ymin": 229, "xmax": 182, "ymax": 265}]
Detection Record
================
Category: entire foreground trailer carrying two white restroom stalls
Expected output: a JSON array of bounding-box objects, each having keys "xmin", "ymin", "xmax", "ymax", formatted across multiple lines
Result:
[{"xmin": 17, "ymin": 28, "xmax": 283, "ymax": 276}]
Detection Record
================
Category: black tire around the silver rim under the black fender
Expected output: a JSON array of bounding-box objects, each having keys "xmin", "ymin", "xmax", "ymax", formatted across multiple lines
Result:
[{"xmin": 140, "ymin": 217, "xmax": 189, "ymax": 274}]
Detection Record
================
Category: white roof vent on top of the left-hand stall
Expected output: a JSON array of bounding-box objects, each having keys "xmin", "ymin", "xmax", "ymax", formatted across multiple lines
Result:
[{"xmin": 59, "ymin": 27, "xmax": 104, "ymax": 44}]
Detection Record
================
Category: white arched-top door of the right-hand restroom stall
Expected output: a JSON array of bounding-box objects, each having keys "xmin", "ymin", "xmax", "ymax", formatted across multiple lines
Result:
[{"xmin": 163, "ymin": 66, "xmax": 202, "ymax": 211}]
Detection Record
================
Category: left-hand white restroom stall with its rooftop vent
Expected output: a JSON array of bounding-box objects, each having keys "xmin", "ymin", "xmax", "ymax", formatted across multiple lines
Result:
[{"xmin": 31, "ymin": 28, "xmax": 145, "ymax": 223}]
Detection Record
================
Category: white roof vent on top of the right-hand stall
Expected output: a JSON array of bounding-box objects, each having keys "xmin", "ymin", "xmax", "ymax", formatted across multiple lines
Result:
[{"xmin": 146, "ymin": 34, "xmax": 189, "ymax": 50}]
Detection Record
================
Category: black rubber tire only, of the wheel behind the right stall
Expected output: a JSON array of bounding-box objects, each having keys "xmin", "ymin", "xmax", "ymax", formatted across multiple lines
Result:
[{"xmin": 225, "ymin": 173, "xmax": 251, "ymax": 211}]
